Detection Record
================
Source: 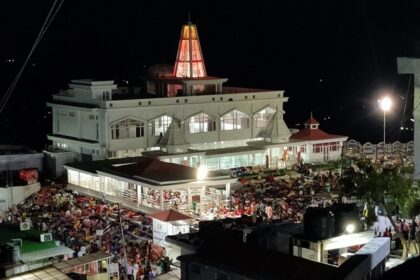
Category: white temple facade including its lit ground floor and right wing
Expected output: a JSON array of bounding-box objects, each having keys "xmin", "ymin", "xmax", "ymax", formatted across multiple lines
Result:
[{"xmin": 48, "ymin": 81, "xmax": 346, "ymax": 169}]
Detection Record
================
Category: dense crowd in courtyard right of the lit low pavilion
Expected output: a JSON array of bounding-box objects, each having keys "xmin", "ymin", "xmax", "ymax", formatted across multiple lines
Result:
[{"xmin": 226, "ymin": 168, "xmax": 339, "ymax": 222}]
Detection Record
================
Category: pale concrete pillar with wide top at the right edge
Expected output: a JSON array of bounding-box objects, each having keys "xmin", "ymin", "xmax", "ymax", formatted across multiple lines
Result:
[{"xmin": 397, "ymin": 57, "xmax": 420, "ymax": 179}]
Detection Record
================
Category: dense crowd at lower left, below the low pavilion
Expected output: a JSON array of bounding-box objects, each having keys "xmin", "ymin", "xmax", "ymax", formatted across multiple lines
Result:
[{"xmin": 2, "ymin": 185, "xmax": 170, "ymax": 280}]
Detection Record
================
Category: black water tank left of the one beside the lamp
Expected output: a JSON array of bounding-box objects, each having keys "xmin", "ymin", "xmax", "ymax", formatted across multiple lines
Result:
[{"xmin": 303, "ymin": 207, "xmax": 335, "ymax": 240}]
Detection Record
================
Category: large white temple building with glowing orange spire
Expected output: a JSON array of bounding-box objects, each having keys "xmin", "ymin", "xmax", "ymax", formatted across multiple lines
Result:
[{"xmin": 45, "ymin": 22, "xmax": 347, "ymax": 175}]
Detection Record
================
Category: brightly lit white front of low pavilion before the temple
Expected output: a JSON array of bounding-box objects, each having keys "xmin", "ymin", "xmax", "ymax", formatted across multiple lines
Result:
[{"xmin": 65, "ymin": 163, "xmax": 236, "ymax": 215}]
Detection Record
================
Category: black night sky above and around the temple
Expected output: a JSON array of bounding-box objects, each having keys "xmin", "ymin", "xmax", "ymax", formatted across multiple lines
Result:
[{"xmin": 0, "ymin": 0, "xmax": 420, "ymax": 149}]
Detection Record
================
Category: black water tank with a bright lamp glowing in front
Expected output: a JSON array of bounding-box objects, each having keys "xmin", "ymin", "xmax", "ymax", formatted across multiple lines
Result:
[{"xmin": 332, "ymin": 203, "xmax": 360, "ymax": 235}]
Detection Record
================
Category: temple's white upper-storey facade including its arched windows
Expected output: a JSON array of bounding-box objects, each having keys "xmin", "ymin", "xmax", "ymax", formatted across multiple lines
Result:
[{"xmin": 48, "ymin": 81, "xmax": 287, "ymax": 166}]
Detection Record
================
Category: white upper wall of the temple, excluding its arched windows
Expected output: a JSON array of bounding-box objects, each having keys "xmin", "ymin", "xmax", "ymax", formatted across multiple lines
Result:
[{"xmin": 49, "ymin": 91, "xmax": 287, "ymax": 160}]
